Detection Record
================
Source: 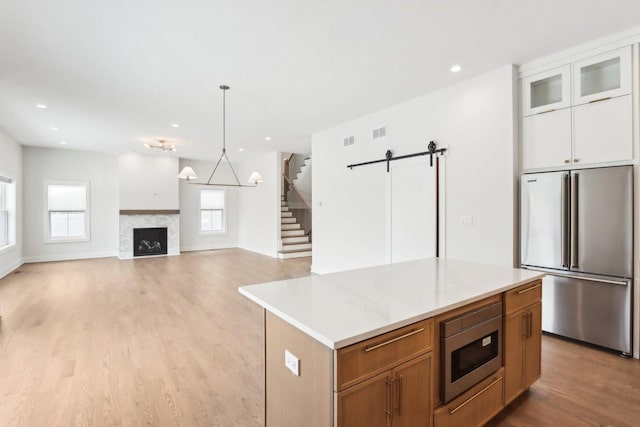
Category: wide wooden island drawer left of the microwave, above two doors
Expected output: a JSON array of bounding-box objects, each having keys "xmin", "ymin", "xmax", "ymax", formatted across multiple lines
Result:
[{"xmin": 335, "ymin": 319, "xmax": 433, "ymax": 391}]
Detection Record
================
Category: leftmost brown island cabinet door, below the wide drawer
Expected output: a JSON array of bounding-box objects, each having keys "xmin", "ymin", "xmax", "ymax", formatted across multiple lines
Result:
[{"xmin": 338, "ymin": 371, "xmax": 393, "ymax": 427}]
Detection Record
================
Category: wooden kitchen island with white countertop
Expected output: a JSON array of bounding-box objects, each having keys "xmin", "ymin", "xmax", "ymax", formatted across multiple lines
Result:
[{"xmin": 239, "ymin": 258, "xmax": 543, "ymax": 427}]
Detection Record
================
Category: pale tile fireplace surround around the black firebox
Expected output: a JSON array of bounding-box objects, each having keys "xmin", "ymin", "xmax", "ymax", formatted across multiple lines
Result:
[{"xmin": 118, "ymin": 210, "xmax": 180, "ymax": 259}]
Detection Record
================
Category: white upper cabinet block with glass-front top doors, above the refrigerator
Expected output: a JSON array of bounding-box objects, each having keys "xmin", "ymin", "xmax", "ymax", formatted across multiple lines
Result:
[{"xmin": 522, "ymin": 46, "xmax": 635, "ymax": 170}]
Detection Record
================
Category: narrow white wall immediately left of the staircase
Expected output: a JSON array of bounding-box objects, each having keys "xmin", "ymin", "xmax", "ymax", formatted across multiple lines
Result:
[{"xmin": 237, "ymin": 151, "xmax": 282, "ymax": 257}]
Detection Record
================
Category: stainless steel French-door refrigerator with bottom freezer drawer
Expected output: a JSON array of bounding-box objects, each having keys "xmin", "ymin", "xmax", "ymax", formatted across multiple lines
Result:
[{"xmin": 520, "ymin": 166, "xmax": 633, "ymax": 354}]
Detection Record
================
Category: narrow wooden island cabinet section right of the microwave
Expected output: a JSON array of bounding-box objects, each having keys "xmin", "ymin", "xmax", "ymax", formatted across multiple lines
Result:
[{"xmin": 504, "ymin": 281, "xmax": 542, "ymax": 405}]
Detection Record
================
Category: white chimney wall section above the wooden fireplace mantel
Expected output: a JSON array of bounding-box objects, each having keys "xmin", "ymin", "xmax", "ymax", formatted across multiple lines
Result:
[{"xmin": 118, "ymin": 153, "xmax": 180, "ymax": 210}]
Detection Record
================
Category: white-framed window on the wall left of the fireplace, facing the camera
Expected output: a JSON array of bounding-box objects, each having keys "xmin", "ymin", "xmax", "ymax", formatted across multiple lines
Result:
[{"xmin": 47, "ymin": 182, "xmax": 89, "ymax": 241}]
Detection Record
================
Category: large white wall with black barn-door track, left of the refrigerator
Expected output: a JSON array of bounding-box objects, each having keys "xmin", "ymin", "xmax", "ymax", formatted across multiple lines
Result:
[{"xmin": 312, "ymin": 66, "xmax": 516, "ymax": 273}]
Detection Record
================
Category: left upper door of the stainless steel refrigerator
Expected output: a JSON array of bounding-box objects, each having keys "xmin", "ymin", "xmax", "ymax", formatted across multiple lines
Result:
[{"xmin": 520, "ymin": 172, "xmax": 567, "ymax": 269}]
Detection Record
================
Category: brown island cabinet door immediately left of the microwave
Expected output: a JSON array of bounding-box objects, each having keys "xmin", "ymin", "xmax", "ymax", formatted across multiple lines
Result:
[{"xmin": 392, "ymin": 353, "xmax": 432, "ymax": 427}]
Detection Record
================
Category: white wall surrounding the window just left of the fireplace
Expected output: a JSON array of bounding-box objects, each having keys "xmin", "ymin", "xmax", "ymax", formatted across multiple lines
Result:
[{"xmin": 23, "ymin": 147, "xmax": 119, "ymax": 262}]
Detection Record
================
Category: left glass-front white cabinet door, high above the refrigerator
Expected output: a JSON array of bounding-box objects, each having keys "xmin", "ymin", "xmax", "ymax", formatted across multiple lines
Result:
[{"xmin": 522, "ymin": 65, "xmax": 571, "ymax": 116}]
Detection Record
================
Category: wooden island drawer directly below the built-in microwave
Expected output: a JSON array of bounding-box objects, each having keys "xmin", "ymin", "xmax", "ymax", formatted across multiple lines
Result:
[{"xmin": 433, "ymin": 369, "xmax": 504, "ymax": 427}]
